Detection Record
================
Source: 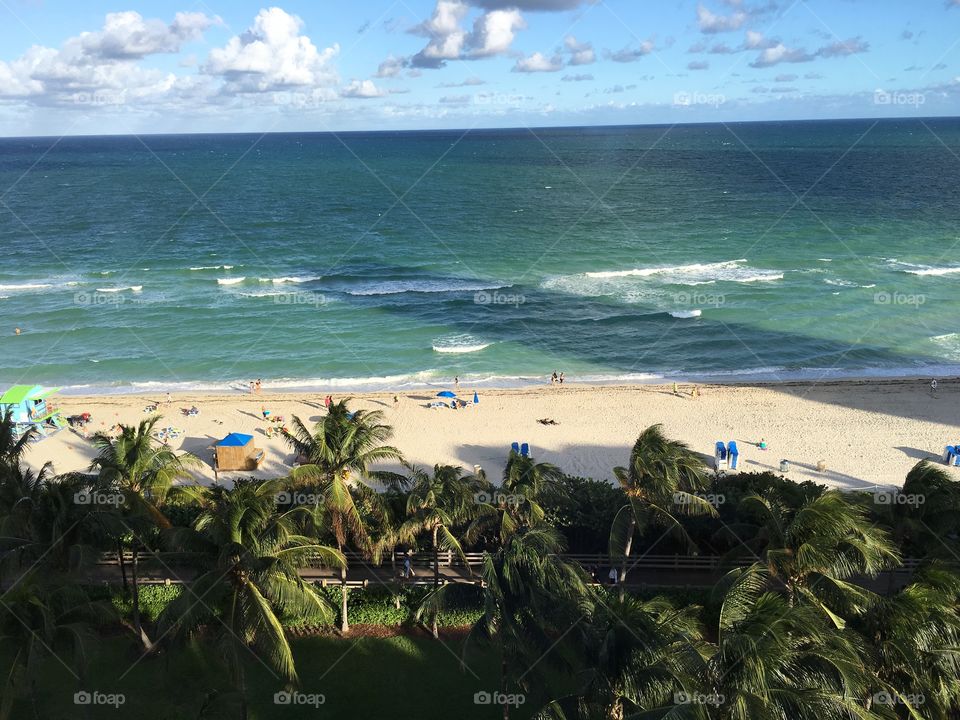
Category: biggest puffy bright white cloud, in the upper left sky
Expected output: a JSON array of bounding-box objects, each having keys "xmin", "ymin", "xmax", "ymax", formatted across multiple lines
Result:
[{"xmin": 203, "ymin": 7, "xmax": 340, "ymax": 93}]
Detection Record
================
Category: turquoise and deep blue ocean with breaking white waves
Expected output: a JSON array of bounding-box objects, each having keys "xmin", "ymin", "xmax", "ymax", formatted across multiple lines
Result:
[{"xmin": 0, "ymin": 120, "xmax": 960, "ymax": 391}]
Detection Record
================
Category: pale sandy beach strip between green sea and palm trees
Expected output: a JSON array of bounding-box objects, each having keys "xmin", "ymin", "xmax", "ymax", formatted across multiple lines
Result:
[{"xmin": 27, "ymin": 380, "xmax": 960, "ymax": 489}]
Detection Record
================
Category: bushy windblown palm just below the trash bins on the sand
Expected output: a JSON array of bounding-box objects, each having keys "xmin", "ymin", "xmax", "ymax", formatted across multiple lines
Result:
[{"xmin": 740, "ymin": 490, "xmax": 899, "ymax": 628}]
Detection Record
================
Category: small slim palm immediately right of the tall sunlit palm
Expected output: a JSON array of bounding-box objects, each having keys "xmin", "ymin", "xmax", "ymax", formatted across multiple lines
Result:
[{"xmin": 400, "ymin": 465, "xmax": 478, "ymax": 587}]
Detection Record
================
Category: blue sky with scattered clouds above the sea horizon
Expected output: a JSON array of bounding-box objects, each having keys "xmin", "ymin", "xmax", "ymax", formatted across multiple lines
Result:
[{"xmin": 0, "ymin": 0, "xmax": 960, "ymax": 136}]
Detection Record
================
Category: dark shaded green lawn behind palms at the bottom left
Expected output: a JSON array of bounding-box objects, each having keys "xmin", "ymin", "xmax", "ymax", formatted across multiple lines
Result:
[{"xmin": 0, "ymin": 637, "xmax": 537, "ymax": 720}]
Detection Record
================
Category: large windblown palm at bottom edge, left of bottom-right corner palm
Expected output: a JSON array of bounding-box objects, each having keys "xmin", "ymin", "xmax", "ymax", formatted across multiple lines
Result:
[{"xmin": 700, "ymin": 565, "xmax": 878, "ymax": 720}]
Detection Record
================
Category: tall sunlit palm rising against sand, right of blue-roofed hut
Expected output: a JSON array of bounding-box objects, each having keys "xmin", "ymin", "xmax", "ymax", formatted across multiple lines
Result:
[{"xmin": 286, "ymin": 400, "xmax": 401, "ymax": 633}]
